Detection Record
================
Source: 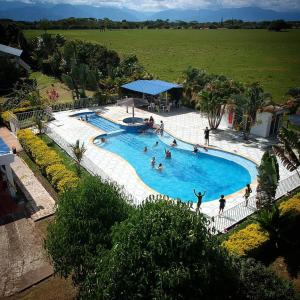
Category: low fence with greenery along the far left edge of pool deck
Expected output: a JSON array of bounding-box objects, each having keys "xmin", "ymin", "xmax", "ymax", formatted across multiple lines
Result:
[{"xmin": 10, "ymin": 95, "xmax": 118, "ymax": 132}]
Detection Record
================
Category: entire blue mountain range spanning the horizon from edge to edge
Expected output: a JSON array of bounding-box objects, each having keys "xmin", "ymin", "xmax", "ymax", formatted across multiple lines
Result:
[{"xmin": 0, "ymin": 0, "xmax": 300, "ymax": 22}]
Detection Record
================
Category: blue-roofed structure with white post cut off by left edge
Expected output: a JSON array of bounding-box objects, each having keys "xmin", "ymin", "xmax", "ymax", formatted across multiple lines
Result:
[{"xmin": 0, "ymin": 138, "xmax": 16, "ymax": 197}]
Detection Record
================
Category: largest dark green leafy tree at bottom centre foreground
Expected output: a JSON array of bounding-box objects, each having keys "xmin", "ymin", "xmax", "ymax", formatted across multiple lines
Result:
[{"xmin": 85, "ymin": 200, "xmax": 238, "ymax": 299}]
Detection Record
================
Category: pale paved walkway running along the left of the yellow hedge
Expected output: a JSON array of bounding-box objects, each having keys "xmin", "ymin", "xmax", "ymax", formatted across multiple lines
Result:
[{"xmin": 0, "ymin": 128, "xmax": 55, "ymax": 221}]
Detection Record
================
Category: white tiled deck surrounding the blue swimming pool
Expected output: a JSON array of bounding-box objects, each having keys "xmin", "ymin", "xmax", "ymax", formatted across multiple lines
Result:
[{"xmin": 48, "ymin": 105, "xmax": 291, "ymax": 216}]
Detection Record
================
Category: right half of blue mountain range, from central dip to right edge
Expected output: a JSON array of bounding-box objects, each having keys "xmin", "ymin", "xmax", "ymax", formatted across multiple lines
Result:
[{"xmin": 151, "ymin": 7, "xmax": 300, "ymax": 22}]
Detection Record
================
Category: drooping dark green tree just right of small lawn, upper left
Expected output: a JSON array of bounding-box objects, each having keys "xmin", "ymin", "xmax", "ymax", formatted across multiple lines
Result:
[{"xmin": 62, "ymin": 63, "xmax": 97, "ymax": 100}]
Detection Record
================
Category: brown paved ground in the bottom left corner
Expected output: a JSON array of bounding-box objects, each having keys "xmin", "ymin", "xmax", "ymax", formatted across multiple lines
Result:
[{"xmin": 0, "ymin": 217, "xmax": 53, "ymax": 299}]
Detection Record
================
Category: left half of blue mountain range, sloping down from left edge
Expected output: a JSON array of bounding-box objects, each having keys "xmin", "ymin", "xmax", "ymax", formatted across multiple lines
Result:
[{"xmin": 0, "ymin": 1, "xmax": 143, "ymax": 21}]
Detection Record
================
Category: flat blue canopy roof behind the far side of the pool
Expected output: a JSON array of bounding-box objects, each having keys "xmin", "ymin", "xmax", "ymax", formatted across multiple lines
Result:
[{"xmin": 122, "ymin": 80, "xmax": 181, "ymax": 95}]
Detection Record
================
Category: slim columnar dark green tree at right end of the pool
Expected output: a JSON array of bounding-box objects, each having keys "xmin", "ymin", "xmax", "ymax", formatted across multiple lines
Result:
[{"xmin": 256, "ymin": 151, "xmax": 279, "ymax": 208}]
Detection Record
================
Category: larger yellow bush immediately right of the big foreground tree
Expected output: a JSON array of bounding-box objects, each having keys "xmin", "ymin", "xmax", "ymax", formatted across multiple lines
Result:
[{"xmin": 222, "ymin": 223, "xmax": 269, "ymax": 256}]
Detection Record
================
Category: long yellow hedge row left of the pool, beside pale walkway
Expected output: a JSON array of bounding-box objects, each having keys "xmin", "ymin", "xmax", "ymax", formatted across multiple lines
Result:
[{"xmin": 18, "ymin": 129, "xmax": 79, "ymax": 193}]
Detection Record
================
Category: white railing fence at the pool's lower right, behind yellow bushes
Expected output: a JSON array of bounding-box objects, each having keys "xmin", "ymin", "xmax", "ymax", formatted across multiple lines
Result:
[{"xmin": 210, "ymin": 171, "xmax": 300, "ymax": 232}]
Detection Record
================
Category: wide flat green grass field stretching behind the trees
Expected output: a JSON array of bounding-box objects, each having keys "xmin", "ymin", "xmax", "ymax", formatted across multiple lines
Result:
[{"xmin": 26, "ymin": 30, "xmax": 300, "ymax": 102}]
